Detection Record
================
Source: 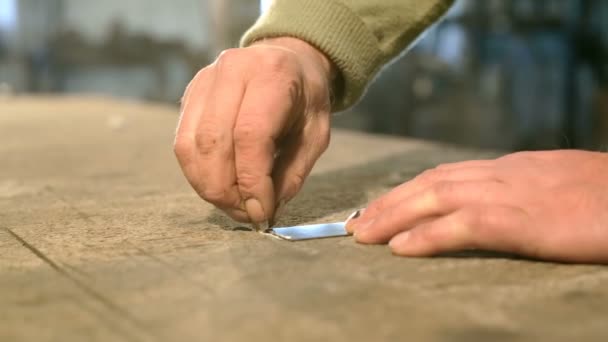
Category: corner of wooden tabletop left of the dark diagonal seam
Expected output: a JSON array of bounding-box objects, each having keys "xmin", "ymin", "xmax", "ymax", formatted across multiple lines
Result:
[{"xmin": 0, "ymin": 227, "xmax": 150, "ymax": 341}]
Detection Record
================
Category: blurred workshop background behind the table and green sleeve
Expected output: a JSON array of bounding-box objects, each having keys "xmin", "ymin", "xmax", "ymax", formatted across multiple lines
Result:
[{"xmin": 0, "ymin": 0, "xmax": 608, "ymax": 150}]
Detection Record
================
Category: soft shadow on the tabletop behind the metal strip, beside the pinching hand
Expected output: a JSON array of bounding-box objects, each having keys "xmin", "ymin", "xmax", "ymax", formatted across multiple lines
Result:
[{"xmin": 208, "ymin": 145, "xmax": 496, "ymax": 231}]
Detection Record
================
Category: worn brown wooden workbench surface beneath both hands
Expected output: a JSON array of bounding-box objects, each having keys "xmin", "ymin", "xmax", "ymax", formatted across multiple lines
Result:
[{"xmin": 0, "ymin": 97, "xmax": 608, "ymax": 341}]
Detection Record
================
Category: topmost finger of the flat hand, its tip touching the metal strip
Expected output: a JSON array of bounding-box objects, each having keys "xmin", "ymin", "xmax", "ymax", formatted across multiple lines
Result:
[{"xmin": 346, "ymin": 167, "xmax": 494, "ymax": 233}]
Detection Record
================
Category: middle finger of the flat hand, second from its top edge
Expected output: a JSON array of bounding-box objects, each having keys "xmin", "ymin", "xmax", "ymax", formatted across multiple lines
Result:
[{"xmin": 354, "ymin": 181, "xmax": 508, "ymax": 243}]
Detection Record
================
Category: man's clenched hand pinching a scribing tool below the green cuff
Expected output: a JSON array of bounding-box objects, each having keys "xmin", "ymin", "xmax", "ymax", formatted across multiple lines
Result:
[{"xmin": 175, "ymin": 38, "xmax": 332, "ymax": 229}]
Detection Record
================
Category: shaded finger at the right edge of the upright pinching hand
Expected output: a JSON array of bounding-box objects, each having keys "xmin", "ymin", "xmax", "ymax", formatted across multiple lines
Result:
[{"xmin": 273, "ymin": 112, "xmax": 330, "ymax": 219}]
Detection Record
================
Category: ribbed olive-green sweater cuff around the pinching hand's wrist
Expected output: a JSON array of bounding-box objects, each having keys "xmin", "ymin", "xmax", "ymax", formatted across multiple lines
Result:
[{"xmin": 241, "ymin": 0, "xmax": 384, "ymax": 112}]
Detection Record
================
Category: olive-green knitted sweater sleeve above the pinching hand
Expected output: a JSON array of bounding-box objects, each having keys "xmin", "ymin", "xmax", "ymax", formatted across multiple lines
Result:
[{"xmin": 241, "ymin": 0, "xmax": 454, "ymax": 111}]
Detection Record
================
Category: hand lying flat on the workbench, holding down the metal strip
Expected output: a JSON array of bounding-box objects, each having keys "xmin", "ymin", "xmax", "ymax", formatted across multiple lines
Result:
[{"xmin": 347, "ymin": 151, "xmax": 608, "ymax": 262}]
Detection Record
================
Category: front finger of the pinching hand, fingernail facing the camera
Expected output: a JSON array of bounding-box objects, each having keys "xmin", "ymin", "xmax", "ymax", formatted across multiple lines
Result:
[{"xmin": 234, "ymin": 79, "xmax": 294, "ymax": 224}]
